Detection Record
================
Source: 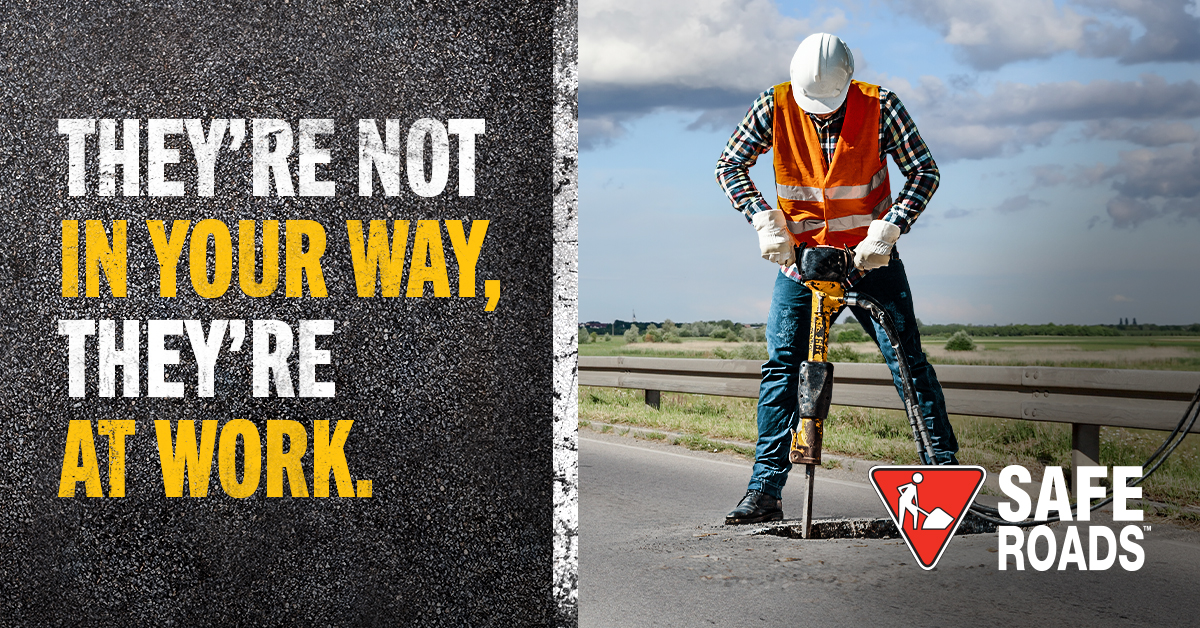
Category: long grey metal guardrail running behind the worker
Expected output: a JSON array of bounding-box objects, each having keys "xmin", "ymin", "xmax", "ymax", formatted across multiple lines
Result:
[{"xmin": 580, "ymin": 355, "xmax": 1200, "ymax": 480}]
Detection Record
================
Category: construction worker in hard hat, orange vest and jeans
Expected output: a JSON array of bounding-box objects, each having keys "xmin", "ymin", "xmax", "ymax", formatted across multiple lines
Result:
[{"xmin": 716, "ymin": 32, "xmax": 959, "ymax": 524}]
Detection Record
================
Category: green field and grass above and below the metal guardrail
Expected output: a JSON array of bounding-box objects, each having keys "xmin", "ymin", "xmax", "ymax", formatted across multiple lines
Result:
[{"xmin": 580, "ymin": 319, "xmax": 1200, "ymax": 511}]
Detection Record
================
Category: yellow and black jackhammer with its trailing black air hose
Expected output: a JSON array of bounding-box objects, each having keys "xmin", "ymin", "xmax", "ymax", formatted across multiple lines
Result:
[{"xmin": 788, "ymin": 246, "xmax": 1200, "ymax": 538}]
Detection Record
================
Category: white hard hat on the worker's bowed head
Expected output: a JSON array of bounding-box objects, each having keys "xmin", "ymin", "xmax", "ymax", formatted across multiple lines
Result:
[{"xmin": 792, "ymin": 32, "xmax": 854, "ymax": 113}]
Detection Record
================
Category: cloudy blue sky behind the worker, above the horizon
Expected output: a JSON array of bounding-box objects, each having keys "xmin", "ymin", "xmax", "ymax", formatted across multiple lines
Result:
[{"xmin": 580, "ymin": 0, "xmax": 1200, "ymax": 324}]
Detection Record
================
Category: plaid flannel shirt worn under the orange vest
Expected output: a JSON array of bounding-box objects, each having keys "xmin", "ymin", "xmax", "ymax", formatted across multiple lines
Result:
[{"xmin": 716, "ymin": 88, "xmax": 940, "ymax": 233}]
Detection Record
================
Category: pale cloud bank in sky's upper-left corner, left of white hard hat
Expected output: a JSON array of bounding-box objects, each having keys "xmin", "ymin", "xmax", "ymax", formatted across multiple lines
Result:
[{"xmin": 580, "ymin": 0, "xmax": 847, "ymax": 149}]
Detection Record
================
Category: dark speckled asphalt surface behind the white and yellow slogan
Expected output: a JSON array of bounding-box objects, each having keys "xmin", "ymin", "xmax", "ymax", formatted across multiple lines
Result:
[{"xmin": 0, "ymin": 0, "xmax": 561, "ymax": 628}]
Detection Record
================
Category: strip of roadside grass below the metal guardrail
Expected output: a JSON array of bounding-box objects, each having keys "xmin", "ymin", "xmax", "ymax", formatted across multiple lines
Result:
[{"xmin": 580, "ymin": 387, "xmax": 1200, "ymax": 506}]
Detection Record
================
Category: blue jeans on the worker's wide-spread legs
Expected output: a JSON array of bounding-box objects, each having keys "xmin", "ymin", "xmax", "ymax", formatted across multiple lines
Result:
[{"xmin": 750, "ymin": 256, "xmax": 959, "ymax": 497}]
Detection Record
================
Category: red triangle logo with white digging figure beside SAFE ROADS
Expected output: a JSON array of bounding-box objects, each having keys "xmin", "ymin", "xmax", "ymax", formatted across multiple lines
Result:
[{"xmin": 870, "ymin": 466, "xmax": 988, "ymax": 569}]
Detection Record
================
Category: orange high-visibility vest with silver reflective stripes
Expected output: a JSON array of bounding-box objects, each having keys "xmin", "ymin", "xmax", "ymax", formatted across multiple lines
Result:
[{"xmin": 773, "ymin": 80, "xmax": 892, "ymax": 247}]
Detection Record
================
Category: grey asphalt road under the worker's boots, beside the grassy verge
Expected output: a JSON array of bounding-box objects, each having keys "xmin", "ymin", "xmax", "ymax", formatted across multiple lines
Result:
[{"xmin": 580, "ymin": 430, "xmax": 1200, "ymax": 628}]
